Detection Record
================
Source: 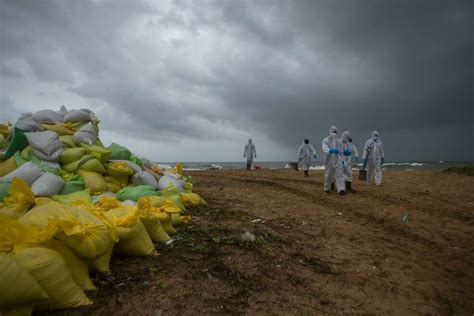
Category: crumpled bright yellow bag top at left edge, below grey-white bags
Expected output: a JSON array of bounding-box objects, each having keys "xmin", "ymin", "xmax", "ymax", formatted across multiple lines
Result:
[{"xmin": 0, "ymin": 177, "xmax": 35, "ymax": 218}]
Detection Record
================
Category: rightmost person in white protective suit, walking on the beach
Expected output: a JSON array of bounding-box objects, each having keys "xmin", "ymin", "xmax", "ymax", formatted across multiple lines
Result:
[{"xmin": 362, "ymin": 131, "xmax": 384, "ymax": 185}]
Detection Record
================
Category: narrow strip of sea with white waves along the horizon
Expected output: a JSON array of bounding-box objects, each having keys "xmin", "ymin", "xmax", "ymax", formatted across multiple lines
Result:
[{"xmin": 158, "ymin": 161, "xmax": 474, "ymax": 171}]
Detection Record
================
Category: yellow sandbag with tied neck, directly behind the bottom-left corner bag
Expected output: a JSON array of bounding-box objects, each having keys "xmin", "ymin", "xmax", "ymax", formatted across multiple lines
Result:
[{"xmin": 0, "ymin": 217, "xmax": 92, "ymax": 310}]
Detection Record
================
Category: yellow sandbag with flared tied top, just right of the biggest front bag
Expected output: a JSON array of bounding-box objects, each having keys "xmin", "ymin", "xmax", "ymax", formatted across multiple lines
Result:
[{"xmin": 105, "ymin": 206, "xmax": 157, "ymax": 256}]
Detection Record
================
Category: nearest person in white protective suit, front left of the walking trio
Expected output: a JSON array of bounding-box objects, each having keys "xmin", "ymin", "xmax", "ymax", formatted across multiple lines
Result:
[{"xmin": 322, "ymin": 125, "xmax": 346, "ymax": 195}]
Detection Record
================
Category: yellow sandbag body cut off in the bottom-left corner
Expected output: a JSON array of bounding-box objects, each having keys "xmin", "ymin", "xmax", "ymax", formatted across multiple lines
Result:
[{"xmin": 0, "ymin": 253, "xmax": 48, "ymax": 310}]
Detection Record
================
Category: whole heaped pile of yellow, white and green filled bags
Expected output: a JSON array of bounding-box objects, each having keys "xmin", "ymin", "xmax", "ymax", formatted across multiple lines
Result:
[{"xmin": 0, "ymin": 107, "xmax": 206, "ymax": 315}]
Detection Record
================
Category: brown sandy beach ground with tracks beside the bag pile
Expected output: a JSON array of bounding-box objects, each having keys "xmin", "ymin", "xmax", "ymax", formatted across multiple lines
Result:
[{"xmin": 52, "ymin": 170, "xmax": 474, "ymax": 315}]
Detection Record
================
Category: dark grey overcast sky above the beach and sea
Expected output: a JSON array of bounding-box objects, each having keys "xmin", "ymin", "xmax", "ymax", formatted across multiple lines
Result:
[{"xmin": 0, "ymin": 0, "xmax": 474, "ymax": 161}]
